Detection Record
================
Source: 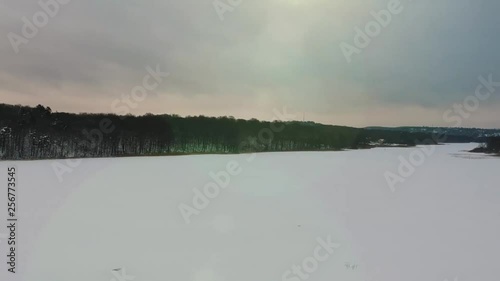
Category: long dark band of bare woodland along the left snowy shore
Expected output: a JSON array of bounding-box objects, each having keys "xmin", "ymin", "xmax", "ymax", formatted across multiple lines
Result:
[{"xmin": 0, "ymin": 104, "xmax": 480, "ymax": 159}]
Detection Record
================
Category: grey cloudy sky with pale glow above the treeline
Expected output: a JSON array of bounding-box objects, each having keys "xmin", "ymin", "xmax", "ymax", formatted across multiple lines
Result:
[{"xmin": 0, "ymin": 0, "xmax": 500, "ymax": 128}]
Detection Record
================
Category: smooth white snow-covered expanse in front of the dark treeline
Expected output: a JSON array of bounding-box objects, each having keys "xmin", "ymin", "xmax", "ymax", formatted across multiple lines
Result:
[{"xmin": 0, "ymin": 144, "xmax": 500, "ymax": 281}]
